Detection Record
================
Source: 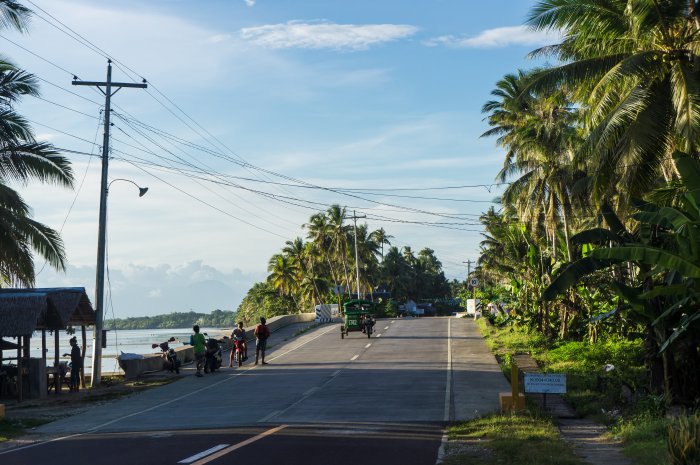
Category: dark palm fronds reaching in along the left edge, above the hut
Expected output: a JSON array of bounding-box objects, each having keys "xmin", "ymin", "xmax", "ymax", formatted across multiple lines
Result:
[{"xmin": 0, "ymin": 0, "xmax": 73, "ymax": 287}]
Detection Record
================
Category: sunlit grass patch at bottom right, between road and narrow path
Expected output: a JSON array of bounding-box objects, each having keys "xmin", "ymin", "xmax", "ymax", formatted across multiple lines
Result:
[{"xmin": 443, "ymin": 412, "xmax": 585, "ymax": 465}]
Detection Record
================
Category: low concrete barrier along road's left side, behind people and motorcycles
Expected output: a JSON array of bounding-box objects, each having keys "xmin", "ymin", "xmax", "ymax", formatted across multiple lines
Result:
[{"xmin": 119, "ymin": 313, "xmax": 316, "ymax": 379}]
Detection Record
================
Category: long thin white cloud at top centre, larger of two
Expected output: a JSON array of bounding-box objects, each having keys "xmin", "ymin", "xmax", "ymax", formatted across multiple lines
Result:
[{"xmin": 241, "ymin": 21, "xmax": 418, "ymax": 50}]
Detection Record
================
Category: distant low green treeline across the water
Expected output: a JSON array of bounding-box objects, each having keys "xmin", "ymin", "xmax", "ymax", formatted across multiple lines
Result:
[{"xmin": 105, "ymin": 309, "xmax": 236, "ymax": 330}]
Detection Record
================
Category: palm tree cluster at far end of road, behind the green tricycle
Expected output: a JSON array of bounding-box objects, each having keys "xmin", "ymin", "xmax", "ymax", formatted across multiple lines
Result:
[{"xmin": 239, "ymin": 205, "xmax": 450, "ymax": 321}]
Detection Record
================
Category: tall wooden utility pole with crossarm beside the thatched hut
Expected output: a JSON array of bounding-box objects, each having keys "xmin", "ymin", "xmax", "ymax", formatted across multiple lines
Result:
[{"xmin": 72, "ymin": 60, "xmax": 147, "ymax": 387}]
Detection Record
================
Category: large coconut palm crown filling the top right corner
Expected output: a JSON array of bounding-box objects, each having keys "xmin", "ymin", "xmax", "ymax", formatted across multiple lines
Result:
[{"xmin": 528, "ymin": 0, "xmax": 700, "ymax": 199}]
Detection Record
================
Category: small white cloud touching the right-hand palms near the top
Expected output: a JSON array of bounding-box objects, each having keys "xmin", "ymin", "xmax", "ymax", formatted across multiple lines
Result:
[{"xmin": 425, "ymin": 26, "xmax": 561, "ymax": 48}]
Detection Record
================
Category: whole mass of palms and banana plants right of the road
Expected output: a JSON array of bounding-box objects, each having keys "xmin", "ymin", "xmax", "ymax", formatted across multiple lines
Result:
[{"xmin": 479, "ymin": 0, "xmax": 700, "ymax": 400}]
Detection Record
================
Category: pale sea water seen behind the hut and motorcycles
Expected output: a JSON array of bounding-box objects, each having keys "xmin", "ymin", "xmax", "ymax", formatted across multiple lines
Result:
[{"xmin": 21, "ymin": 328, "xmax": 233, "ymax": 375}]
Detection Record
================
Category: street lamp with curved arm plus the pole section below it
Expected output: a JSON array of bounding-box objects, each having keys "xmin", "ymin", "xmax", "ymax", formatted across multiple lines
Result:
[{"xmin": 90, "ymin": 176, "xmax": 148, "ymax": 387}]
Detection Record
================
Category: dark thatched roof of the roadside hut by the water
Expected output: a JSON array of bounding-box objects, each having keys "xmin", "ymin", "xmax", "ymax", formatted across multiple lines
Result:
[{"xmin": 0, "ymin": 287, "xmax": 95, "ymax": 337}]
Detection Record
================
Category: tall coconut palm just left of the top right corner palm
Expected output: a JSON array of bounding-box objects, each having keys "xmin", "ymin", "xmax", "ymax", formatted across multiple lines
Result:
[{"xmin": 482, "ymin": 71, "xmax": 582, "ymax": 261}]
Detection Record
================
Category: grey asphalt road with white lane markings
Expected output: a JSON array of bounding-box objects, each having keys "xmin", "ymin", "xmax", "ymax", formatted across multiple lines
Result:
[{"xmin": 0, "ymin": 318, "xmax": 505, "ymax": 465}]
